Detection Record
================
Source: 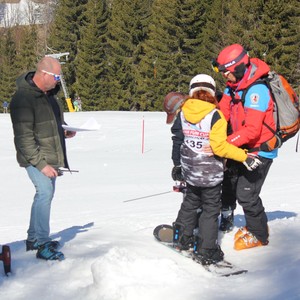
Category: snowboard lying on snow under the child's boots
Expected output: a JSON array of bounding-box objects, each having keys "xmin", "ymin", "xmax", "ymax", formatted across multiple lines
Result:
[{"xmin": 153, "ymin": 224, "xmax": 248, "ymax": 277}]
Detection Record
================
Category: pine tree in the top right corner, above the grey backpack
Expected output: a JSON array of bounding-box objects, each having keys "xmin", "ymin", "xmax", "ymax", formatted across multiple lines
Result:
[{"xmin": 254, "ymin": 0, "xmax": 300, "ymax": 86}]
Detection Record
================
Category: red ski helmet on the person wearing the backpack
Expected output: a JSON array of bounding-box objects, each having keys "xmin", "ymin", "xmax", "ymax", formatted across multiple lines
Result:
[{"xmin": 214, "ymin": 44, "xmax": 249, "ymax": 73}]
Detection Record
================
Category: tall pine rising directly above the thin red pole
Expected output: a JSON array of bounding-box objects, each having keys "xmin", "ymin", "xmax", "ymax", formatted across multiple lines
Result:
[{"xmin": 138, "ymin": 0, "xmax": 184, "ymax": 110}]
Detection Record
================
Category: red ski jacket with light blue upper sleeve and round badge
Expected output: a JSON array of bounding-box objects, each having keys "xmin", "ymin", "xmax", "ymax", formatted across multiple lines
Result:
[{"xmin": 220, "ymin": 58, "xmax": 277, "ymax": 159}]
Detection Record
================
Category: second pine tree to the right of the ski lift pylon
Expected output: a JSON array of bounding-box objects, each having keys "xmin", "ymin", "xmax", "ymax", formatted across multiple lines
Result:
[{"xmin": 107, "ymin": 0, "xmax": 150, "ymax": 110}]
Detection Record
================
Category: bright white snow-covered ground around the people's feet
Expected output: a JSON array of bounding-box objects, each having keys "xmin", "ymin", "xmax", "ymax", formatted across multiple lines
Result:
[{"xmin": 0, "ymin": 112, "xmax": 300, "ymax": 300}]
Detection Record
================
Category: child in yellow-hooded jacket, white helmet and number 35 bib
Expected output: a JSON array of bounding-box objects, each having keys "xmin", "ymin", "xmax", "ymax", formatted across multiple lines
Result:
[{"xmin": 171, "ymin": 74, "xmax": 260, "ymax": 264}]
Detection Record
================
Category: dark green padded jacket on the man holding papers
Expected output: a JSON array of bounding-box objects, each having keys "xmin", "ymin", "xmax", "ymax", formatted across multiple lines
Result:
[{"xmin": 10, "ymin": 72, "xmax": 65, "ymax": 171}]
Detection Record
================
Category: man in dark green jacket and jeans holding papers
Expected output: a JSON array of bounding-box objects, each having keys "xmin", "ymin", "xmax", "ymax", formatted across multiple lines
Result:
[{"xmin": 10, "ymin": 57, "xmax": 75, "ymax": 260}]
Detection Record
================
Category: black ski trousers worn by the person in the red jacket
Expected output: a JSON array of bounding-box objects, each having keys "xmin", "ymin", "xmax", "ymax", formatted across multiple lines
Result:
[{"xmin": 221, "ymin": 157, "xmax": 273, "ymax": 243}]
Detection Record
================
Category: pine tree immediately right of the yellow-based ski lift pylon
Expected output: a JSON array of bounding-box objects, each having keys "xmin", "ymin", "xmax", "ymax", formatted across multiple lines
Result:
[{"xmin": 73, "ymin": 0, "xmax": 108, "ymax": 110}]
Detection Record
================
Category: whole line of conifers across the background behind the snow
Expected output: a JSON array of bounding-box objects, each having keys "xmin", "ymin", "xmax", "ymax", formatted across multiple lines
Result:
[{"xmin": 0, "ymin": 0, "xmax": 300, "ymax": 110}]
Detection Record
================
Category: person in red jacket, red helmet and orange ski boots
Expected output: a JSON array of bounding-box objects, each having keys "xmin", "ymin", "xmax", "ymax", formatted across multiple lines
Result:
[{"xmin": 213, "ymin": 44, "xmax": 277, "ymax": 250}]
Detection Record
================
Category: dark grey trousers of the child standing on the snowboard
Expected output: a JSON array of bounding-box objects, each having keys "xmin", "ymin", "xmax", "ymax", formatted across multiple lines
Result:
[{"xmin": 176, "ymin": 184, "xmax": 221, "ymax": 249}]
